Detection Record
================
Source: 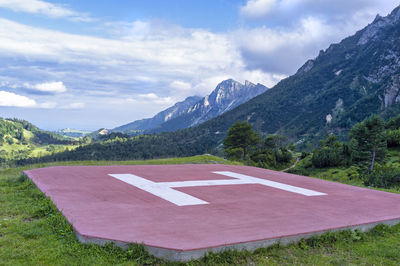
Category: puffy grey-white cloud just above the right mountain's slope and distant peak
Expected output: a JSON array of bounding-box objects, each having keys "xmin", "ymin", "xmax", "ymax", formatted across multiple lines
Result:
[{"xmin": 236, "ymin": 17, "xmax": 336, "ymax": 74}]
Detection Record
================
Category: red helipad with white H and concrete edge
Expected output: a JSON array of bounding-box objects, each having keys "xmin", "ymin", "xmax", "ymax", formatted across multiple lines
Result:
[{"xmin": 25, "ymin": 164, "xmax": 400, "ymax": 261}]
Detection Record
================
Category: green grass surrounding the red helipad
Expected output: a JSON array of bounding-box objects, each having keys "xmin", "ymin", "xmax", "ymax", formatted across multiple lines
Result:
[{"xmin": 0, "ymin": 155, "xmax": 400, "ymax": 265}]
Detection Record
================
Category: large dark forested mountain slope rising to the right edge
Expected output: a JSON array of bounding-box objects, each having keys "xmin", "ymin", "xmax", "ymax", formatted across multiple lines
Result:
[{"xmin": 32, "ymin": 4, "xmax": 400, "ymax": 162}]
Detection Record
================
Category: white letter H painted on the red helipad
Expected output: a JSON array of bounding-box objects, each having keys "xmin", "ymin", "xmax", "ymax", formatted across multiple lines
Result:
[{"xmin": 109, "ymin": 171, "xmax": 326, "ymax": 206}]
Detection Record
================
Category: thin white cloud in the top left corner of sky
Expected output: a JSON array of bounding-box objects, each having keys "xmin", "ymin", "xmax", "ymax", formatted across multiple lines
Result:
[{"xmin": 0, "ymin": 0, "xmax": 92, "ymax": 22}]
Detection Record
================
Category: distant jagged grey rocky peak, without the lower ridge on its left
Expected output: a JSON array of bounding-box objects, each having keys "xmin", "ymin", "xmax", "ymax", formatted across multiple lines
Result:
[{"xmin": 150, "ymin": 79, "xmax": 268, "ymax": 133}]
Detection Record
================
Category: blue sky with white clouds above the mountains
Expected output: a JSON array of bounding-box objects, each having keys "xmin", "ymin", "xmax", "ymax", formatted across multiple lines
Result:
[{"xmin": 0, "ymin": 0, "xmax": 399, "ymax": 130}]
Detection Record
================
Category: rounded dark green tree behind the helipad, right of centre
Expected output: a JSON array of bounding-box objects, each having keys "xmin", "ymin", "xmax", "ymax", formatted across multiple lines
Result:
[{"xmin": 224, "ymin": 122, "xmax": 260, "ymax": 159}]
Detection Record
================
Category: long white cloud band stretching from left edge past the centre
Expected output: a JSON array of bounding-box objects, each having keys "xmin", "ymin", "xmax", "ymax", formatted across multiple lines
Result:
[{"xmin": 0, "ymin": 19, "xmax": 238, "ymax": 71}]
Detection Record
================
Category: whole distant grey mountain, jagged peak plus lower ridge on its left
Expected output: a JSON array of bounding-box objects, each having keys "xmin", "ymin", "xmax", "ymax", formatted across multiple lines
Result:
[{"xmin": 112, "ymin": 79, "xmax": 268, "ymax": 133}]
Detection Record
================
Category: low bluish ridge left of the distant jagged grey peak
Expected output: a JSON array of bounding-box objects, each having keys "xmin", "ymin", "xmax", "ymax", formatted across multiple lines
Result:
[{"xmin": 111, "ymin": 96, "xmax": 201, "ymax": 134}]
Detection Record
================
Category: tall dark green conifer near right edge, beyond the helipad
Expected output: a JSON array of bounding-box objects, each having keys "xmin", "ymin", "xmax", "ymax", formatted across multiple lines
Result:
[{"xmin": 350, "ymin": 115, "xmax": 387, "ymax": 173}]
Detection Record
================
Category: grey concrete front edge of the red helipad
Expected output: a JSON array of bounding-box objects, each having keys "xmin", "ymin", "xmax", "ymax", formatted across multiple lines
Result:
[{"xmin": 75, "ymin": 219, "xmax": 400, "ymax": 262}]
